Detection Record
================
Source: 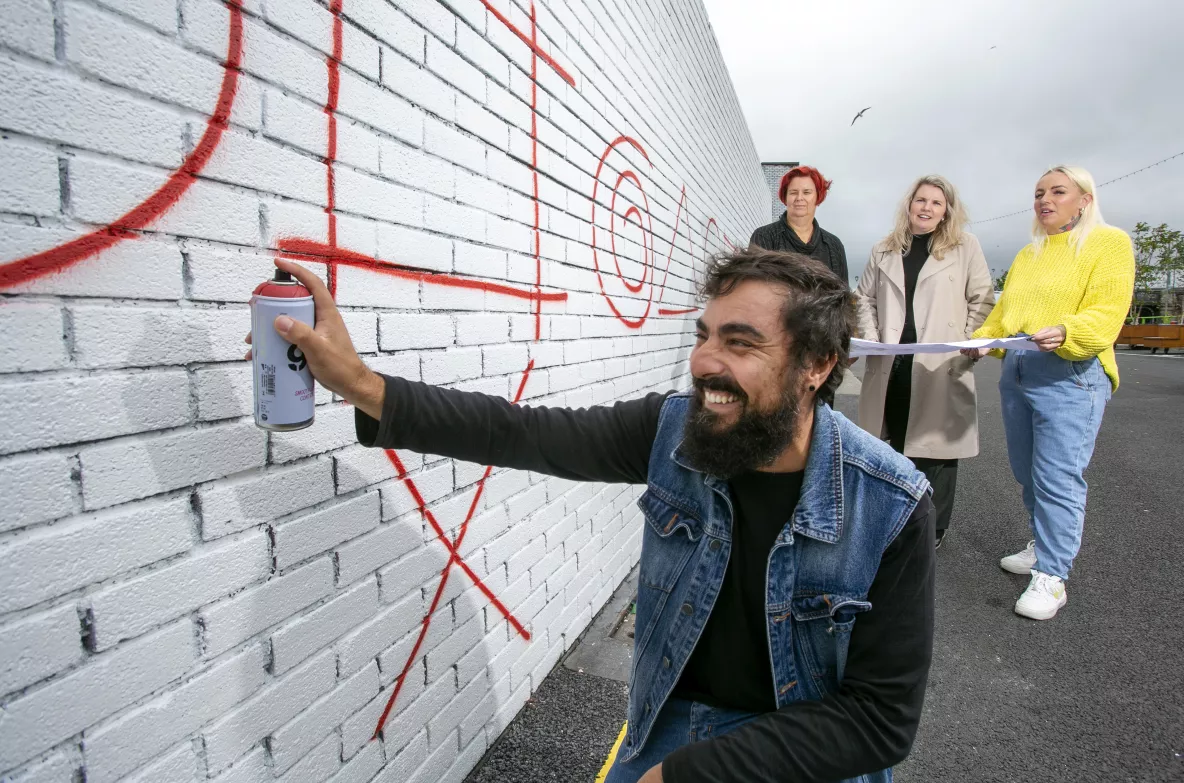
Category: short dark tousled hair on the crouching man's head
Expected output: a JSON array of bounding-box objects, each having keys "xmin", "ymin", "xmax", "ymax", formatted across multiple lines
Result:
[{"xmin": 700, "ymin": 248, "xmax": 856, "ymax": 399}]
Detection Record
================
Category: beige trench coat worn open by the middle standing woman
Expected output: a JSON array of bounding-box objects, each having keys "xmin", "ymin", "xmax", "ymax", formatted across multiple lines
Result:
[{"xmin": 855, "ymin": 233, "xmax": 995, "ymax": 460}]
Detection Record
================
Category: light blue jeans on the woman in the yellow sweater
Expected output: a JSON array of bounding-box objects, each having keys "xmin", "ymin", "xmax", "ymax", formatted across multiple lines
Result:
[{"xmin": 999, "ymin": 351, "xmax": 1111, "ymax": 579}]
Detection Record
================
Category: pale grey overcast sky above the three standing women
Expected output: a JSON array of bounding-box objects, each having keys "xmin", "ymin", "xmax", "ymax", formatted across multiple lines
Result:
[{"xmin": 704, "ymin": 0, "xmax": 1184, "ymax": 284}]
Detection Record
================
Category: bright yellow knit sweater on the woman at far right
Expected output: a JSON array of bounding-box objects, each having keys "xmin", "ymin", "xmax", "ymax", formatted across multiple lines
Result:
[{"xmin": 974, "ymin": 226, "xmax": 1134, "ymax": 389}]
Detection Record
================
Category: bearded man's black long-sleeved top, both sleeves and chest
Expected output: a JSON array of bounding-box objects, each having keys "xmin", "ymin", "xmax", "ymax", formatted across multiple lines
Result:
[{"xmin": 355, "ymin": 378, "xmax": 935, "ymax": 783}]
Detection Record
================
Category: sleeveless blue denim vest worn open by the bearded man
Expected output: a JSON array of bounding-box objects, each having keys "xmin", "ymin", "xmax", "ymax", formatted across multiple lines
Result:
[{"xmin": 619, "ymin": 393, "xmax": 929, "ymax": 783}]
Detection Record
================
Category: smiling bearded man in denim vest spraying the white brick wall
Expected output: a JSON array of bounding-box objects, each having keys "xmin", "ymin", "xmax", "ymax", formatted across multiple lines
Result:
[{"xmin": 256, "ymin": 249, "xmax": 934, "ymax": 783}]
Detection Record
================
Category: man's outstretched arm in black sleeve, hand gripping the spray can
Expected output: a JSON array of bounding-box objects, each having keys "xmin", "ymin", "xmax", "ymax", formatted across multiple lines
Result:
[{"xmin": 251, "ymin": 261, "xmax": 665, "ymax": 483}]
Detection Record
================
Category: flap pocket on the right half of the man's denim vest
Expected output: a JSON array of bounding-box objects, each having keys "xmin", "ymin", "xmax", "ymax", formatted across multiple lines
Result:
[{"xmin": 790, "ymin": 592, "xmax": 871, "ymax": 694}]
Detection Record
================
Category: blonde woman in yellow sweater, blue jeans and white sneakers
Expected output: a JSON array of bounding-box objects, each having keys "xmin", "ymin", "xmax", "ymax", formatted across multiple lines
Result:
[{"xmin": 963, "ymin": 166, "xmax": 1134, "ymax": 620}]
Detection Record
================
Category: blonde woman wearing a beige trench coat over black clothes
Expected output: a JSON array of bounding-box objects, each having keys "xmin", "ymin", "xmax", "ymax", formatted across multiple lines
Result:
[{"xmin": 856, "ymin": 174, "xmax": 995, "ymax": 546}]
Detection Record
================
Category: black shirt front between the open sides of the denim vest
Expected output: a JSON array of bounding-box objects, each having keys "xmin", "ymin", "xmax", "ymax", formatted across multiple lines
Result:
[{"xmin": 675, "ymin": 470, "xmax": 804, "ymax": 712}]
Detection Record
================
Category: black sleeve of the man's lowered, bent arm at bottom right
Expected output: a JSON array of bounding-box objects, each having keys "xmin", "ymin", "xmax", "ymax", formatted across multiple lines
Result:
[{"xmin": 662, "ymin": 495, "xmax": 937, "ymax": 783}]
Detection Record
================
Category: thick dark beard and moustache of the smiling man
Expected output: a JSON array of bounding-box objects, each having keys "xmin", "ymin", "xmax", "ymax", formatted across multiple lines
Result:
[{"xmin": 682, "ymin": 373, "xmax": 802, "ymax": 479}]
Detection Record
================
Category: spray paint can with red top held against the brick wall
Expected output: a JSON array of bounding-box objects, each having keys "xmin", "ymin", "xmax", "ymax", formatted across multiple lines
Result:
[{"xmin": 251, "ymin": 269, "xmax": 316, "ymax": 432}]
